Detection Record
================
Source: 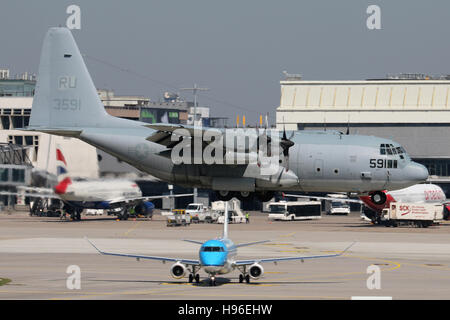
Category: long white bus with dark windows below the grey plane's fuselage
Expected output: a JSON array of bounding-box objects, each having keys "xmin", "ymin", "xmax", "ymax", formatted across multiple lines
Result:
[{"xmin": 268, "ymin": 201, "xmax": 322, "ymax": 220}]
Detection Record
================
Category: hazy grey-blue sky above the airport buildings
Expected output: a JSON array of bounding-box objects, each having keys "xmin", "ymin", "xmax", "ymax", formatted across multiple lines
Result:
[{"xmin": 0, "ymin": 0, "xmax": 450, "ymax": 123}]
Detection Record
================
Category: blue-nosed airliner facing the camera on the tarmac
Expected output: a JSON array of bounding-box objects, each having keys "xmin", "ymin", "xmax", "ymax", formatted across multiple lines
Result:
[{"xmin": 86, "ymin": 203, "xmax": 354, "ymax": 286}]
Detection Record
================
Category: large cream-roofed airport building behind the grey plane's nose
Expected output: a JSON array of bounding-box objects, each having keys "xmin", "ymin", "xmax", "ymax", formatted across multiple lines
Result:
[{"xmin": 276, "ymin": 74, "xmax": 450, "ymax": 197}]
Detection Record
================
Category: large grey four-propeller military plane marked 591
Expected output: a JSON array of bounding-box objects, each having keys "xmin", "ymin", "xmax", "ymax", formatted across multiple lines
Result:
[{"xmin": 25, "ymin": 28, "xmax": 428, "ymax": 202}]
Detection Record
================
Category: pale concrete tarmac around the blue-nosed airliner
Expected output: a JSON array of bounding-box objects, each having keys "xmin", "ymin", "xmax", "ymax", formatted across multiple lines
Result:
[{"xmin": 0, "ymin": 212, "xmax": 450, "ymax": 300}]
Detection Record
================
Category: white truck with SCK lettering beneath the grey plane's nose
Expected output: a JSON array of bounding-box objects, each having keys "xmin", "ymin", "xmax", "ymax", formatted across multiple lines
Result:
[{"xmin": 383, "ymin": 202, "xmax": 444, "ymax": 228}]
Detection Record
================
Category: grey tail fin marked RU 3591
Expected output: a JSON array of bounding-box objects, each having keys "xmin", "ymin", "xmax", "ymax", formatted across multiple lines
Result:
[{"xmin": 28, "ymin": 28, "xmax": 123, "ymax": 130}]
